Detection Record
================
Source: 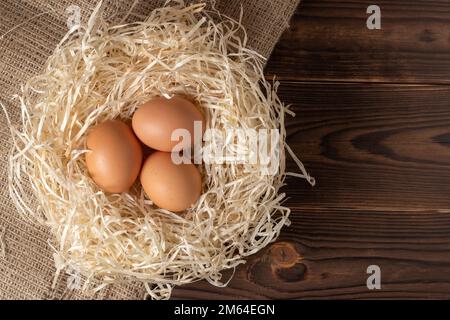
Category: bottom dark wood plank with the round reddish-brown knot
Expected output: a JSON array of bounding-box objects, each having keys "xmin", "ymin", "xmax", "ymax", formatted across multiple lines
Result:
[{"xmin": 173, "ymin": 209, "xmax": 450, "ymax": 299}]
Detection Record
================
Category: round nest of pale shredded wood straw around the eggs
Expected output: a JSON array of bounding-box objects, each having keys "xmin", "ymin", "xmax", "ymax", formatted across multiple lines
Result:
[{"xmin": 4, "ymin": 4, "xmax": 314, "ymax": 299}]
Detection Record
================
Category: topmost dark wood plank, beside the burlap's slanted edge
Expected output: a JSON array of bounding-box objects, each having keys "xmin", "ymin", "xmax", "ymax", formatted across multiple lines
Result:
[{"xmin": 267, "ymin": 0, "xmax": 450, "ymax": 84}]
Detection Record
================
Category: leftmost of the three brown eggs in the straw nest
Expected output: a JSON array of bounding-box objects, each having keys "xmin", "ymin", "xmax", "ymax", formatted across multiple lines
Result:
[{"xmin": 86, "ymin": 120, "xmax": 142, "ymax": 193}]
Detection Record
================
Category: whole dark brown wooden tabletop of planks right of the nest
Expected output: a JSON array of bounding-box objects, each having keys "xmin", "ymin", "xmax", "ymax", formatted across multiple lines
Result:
[{"xmin": 173, "ymin": 0, "xmax": 450, "ymax": 299}]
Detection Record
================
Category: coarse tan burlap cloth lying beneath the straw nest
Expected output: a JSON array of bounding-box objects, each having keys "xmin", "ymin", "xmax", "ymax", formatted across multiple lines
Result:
[{"xmin": 0, "ymin": 0, "xmax": 299, "ymax": 299}]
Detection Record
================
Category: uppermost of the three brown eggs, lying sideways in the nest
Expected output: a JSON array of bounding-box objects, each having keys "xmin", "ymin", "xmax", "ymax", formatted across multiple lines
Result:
[{"xmin": 132, "ymin": 96, "xmax": 205, "ymax": 152}]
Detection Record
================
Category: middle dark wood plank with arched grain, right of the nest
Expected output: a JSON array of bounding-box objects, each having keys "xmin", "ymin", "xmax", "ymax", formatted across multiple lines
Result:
[{"xmin": 280, "ymin": 83, "xmax": 450, "ymax": 213}]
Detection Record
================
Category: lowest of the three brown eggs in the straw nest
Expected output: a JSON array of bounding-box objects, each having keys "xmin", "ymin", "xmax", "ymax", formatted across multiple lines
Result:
[{"xmin": 141, "ymin": 151, "xmax": 202, "ymax": 212}]
